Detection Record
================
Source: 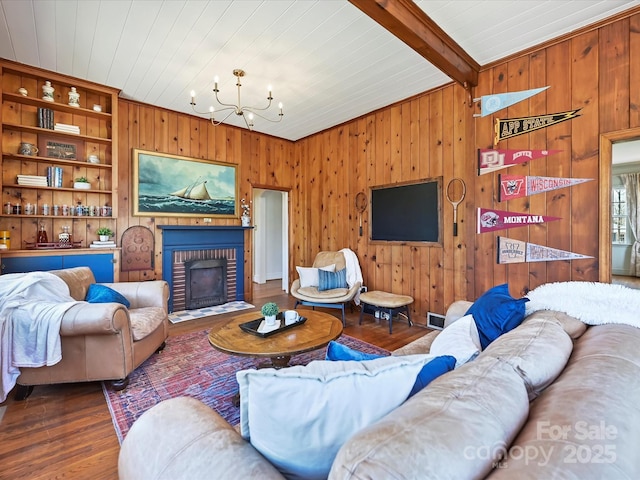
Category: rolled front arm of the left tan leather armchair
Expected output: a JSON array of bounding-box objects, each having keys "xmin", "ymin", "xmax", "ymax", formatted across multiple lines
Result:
[{"xmin": 60, "ymin": 302, "xmax": 129, "ymax": 337}]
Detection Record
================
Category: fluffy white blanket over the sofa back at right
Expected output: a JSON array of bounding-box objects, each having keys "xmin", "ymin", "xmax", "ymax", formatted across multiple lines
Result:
[{"xmin": 525, "ymin": 282, "xmax": 640, "ymax": 328}]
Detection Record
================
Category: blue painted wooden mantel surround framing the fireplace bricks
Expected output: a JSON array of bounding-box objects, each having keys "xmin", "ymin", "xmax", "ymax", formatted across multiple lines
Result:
[{"xmin": 158, "ymin": 225, "xmax": 253, "ymax": 312}]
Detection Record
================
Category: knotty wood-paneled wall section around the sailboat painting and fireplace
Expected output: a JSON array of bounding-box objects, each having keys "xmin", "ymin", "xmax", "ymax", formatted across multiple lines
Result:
[{"xmin": 117, "ymin": 99, "xmax": 295, "ymax": 298}]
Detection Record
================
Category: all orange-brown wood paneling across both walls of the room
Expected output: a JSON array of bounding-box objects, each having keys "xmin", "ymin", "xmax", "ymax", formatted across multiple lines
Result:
[{"xmin": 5, "ymin": 9, "xmax": 640, "ymax": 323}]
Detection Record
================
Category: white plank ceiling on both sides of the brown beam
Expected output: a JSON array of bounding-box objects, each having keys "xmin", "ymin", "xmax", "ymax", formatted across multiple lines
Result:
[{"xmin": 0, "ymin": 0, "xmax": 640, "ymax": 140}]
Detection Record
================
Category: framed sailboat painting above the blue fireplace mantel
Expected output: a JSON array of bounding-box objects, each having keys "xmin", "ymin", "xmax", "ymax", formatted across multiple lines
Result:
[{"xmin": 132, "ymin": 149, "xmax": 238, "ymax": 218}]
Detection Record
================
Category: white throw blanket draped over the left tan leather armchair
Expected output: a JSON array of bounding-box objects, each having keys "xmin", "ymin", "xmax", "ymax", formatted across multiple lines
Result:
[{"xmin": 0, "ymin": 272, "xmax": 78, "ymax": 402}]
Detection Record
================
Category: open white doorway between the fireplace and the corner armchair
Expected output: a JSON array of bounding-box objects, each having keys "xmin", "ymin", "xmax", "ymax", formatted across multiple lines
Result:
[{"xmin": 253, "ymin": 188, "xmax": 289, "ymax": 297}]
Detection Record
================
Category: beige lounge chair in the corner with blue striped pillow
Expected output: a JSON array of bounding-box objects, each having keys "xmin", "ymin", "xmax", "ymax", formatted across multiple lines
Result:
[{"xmin": 291, "ymin": 252, "xmax": 362, "ymax": 326}]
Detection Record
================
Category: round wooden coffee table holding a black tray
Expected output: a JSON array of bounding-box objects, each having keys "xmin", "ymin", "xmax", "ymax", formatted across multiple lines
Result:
[{"xmin": 209, "ymin": 310, "xmax": 342, "ymax": 368}]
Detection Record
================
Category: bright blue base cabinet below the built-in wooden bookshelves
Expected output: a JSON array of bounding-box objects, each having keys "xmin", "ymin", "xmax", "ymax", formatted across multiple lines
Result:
[{"xmin": 2, "ymin": 252, "xmax": 114, "ymax": 283}]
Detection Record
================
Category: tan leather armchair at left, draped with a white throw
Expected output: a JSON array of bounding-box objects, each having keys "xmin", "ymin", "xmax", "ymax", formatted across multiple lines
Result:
[{"xmin": 15, "ymin": 267, "xmax": 169, "ymax": 400}]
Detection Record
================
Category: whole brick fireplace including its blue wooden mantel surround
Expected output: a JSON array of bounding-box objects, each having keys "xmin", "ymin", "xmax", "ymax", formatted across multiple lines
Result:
[{"xmin": 158, "ymin": 225, "xmax": 250, "ymax": 312}]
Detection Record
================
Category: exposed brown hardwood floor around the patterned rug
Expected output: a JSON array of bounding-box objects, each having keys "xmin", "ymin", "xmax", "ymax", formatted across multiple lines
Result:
[{"xmin": 0, "ymin": 280, "xmax": 429, "ymax": 480}]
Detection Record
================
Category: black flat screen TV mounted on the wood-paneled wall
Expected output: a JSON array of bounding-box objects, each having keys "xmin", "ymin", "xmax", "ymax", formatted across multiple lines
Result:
[{"xmin": 371, "ymin": 177, "xmax": 442, "ymax": 243}]
